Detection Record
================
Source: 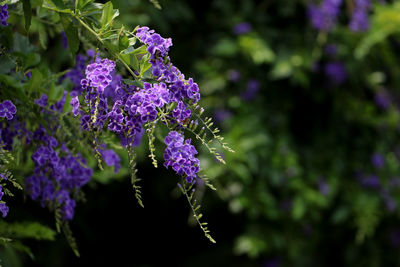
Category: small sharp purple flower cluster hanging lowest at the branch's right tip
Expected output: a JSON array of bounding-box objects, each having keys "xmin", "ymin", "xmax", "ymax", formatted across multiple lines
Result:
[{"xmin": 164, "ymin": 131, "xmax": 200, "ymax": 183}]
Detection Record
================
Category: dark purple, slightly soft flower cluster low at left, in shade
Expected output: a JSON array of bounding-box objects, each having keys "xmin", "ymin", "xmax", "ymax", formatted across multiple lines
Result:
[{"xmin": 25, "ymin": 127, "xmax": 92, "ymax": 220}]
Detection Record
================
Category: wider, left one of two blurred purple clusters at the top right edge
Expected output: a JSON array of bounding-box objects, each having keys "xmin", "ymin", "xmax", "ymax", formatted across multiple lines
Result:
[{"xmin": 308, "ymin": 0, "xmax": 342, "ymax": 32}]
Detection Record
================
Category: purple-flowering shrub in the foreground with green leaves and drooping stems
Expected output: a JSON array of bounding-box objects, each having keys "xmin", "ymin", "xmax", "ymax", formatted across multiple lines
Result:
[{"xmin": 0, "ymin": 0, "xmax": 233, "ymax": 254}]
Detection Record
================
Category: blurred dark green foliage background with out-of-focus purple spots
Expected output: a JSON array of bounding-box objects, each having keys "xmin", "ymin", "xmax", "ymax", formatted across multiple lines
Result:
[{"xmin": 1, "ymin": 0, "xmax": 400, "ymax": 267}]
